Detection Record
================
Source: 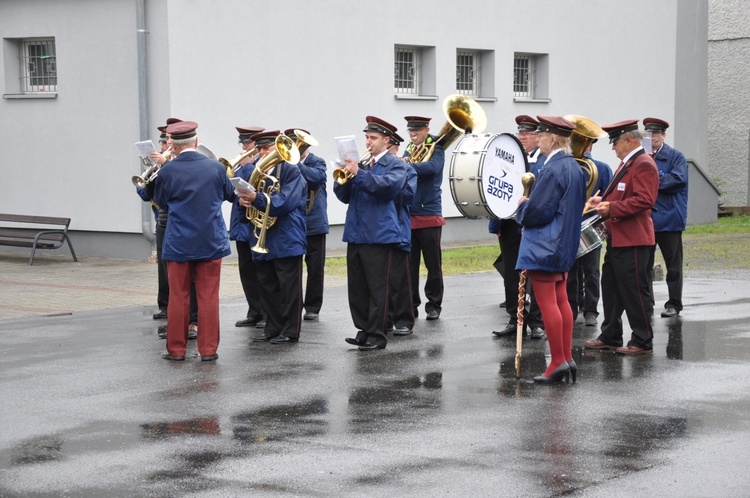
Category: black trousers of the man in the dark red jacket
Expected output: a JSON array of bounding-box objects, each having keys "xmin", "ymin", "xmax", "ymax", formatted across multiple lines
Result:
[{"xmin": 599, "ymin": 246, "xmax": 654, "ymax": 349}]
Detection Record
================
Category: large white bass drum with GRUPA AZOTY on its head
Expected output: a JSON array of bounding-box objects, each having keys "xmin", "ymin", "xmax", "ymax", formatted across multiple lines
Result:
[{"xmin": 448, "ymin": 133, "xmax": 528, "ymax": 219}]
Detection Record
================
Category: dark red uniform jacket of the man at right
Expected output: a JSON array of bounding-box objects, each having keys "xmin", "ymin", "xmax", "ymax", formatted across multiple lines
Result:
[{"xmin": 602, "ymin": 151, "xmax": 659, "ymax": 247}]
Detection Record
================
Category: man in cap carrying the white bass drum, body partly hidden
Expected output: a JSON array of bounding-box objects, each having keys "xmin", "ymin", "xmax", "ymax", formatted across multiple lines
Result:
[{"xmin": 489, "ymin": 114, "xmax": 547, "ymax": 339}]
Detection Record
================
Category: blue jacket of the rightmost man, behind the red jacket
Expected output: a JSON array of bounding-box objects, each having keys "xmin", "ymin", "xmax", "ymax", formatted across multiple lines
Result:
[{"xmin": 651, "ymin": 144, "xmax": 688, "ymax": 232}]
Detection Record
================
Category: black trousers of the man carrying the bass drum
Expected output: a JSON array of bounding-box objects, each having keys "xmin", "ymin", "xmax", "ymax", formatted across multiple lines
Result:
[{"xmin": 498, "ymin": 219, "xmax": 544, "ymax": 328}]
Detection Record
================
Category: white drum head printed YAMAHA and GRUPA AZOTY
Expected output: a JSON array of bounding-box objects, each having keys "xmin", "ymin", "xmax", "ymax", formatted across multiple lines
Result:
[{"xmin": 481, "ymin": 133, "xmax": 528, "ymax": 219}]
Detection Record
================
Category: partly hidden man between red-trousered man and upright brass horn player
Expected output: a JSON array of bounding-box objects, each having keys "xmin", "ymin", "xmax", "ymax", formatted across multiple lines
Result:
[{"xmin": 229, "ymin": 126, "xmax": 266, "ymax": 328}]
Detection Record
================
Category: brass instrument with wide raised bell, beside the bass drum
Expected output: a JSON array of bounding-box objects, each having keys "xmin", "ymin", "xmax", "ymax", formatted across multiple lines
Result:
[{"xmin": 404, "ymin": 94, "xmax": 487, "ymax": 163}]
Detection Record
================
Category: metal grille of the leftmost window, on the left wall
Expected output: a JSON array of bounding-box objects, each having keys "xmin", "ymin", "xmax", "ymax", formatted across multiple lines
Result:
[{"xmin": 19, "ymin": 38, "xmax": 57, "ymax": 92}]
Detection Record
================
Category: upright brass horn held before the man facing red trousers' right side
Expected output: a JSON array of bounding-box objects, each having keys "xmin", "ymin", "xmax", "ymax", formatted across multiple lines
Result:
[{"xmin": 245, "ymin": 135, "xmax": 299, "ymax": 254}]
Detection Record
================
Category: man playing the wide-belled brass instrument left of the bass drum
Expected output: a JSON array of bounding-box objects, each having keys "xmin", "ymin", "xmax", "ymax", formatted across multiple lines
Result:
[{"xmin": 404, "ymin": 116, "xmax": 445, "ymax": 320}]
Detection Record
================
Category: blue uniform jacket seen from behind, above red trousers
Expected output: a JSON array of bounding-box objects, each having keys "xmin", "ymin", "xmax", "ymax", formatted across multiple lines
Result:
[{"xmin": 154, "ymin": 150, "xmax": 234, "ymax": 262}]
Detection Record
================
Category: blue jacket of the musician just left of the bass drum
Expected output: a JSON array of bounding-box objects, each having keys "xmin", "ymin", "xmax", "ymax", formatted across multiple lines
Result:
[{"xmin": 404, "ymin": 135, "xmax": 445, "ymax": 216}]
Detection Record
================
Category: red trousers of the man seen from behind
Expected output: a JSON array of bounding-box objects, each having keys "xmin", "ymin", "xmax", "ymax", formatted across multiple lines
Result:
[{"xmin": 167, "ymin": 258, "xmax": 221, "ymax": 356}]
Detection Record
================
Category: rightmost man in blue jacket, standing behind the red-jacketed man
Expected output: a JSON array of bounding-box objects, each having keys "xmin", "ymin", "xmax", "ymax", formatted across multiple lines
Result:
[{"xmin": 643, "ymin": 118, "xmax": 688, "ymax": 318}]
